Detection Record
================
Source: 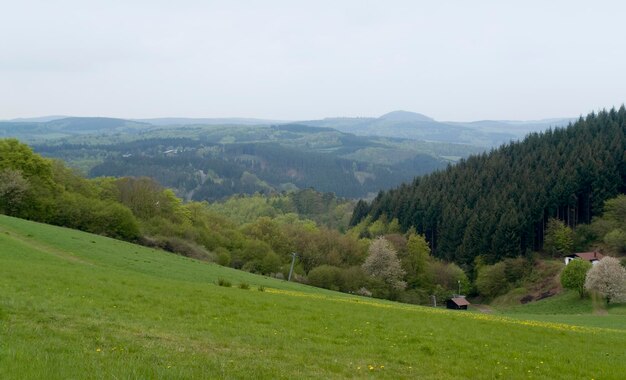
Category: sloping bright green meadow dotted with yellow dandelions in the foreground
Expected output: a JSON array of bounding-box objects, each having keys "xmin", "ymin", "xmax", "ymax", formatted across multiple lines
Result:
[{"xmin": 0, "ymin": 216, "xmax": 626, "ymax": 379}]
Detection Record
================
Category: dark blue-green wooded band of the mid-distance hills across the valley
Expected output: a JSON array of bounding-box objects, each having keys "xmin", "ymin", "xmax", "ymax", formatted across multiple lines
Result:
[{"xmin": 84, "ymin": 142, "xmax": 443, "ymax": 200}]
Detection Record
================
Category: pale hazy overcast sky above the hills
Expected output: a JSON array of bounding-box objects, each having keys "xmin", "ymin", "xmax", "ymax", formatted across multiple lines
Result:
[{"xmin": 0, "ymin": 0, "xmax": 626, "ymax": 120}]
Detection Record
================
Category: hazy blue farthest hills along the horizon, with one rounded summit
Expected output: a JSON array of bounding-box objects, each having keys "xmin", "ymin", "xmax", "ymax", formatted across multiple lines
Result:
[{"xmin": 0, "ymin": 111, "xmax": 575, "ymax": 147}]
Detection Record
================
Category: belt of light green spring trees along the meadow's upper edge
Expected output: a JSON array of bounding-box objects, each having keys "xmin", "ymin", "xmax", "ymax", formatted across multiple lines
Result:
[{"xmin": 0, "ymin": 139, "xmax": 469, "ymax": 303}]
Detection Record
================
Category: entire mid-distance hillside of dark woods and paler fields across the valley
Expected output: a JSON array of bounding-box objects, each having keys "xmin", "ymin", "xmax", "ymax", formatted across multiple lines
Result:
[{"xmin": 35, "ymin": 125, "xmax": 481, "ymax": 200}]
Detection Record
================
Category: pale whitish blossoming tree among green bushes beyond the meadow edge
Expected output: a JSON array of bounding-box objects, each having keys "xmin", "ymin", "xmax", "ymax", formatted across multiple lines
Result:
[{"xmin": 363, "ymin": 236, "xmax": 406, "ymax": 290}]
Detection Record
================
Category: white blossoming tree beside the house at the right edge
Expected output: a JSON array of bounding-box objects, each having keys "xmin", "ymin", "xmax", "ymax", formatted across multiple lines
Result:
[{"xmin": 585, "ymin": 256, "xmax": 626, "ymax": 304}]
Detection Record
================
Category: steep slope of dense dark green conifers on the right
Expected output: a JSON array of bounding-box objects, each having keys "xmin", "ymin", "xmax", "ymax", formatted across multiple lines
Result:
[{"xmin": 352, "ymin": 106, "xmax": 626, "ymax": 265}]
